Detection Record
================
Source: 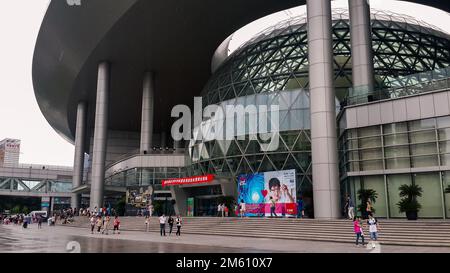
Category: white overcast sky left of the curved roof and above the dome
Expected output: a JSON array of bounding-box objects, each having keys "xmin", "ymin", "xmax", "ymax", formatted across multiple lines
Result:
[{"xmin": 0, "ymin": 0, "xmax": 450, "ymax": 166}]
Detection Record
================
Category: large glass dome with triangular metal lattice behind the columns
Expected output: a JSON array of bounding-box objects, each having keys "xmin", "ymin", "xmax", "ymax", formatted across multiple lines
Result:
[{"xmin": 189, "ymin": 9, "xmax": 450, "ymax": 194}]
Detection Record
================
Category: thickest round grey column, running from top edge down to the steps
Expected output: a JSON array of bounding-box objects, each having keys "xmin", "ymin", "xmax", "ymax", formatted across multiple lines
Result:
[{"xmin": 306, "ymin": 0, "xmax": 341, "ymax": 219}]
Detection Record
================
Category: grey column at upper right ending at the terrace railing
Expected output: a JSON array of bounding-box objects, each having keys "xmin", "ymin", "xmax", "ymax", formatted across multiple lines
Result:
[{"xmin": 348, "ymin": 0, "xmax": 374, "ymax": 102}]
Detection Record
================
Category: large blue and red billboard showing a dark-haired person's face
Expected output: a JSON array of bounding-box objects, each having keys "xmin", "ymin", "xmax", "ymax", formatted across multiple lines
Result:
[{"xmin": 238, "ymin": 170, "xmax": 297, "ymax": 217}]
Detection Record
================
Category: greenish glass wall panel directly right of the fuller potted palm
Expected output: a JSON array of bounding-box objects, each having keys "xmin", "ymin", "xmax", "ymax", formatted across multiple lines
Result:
[{"xmin": 414, "ymin": 173, "xmax": 442, "ymax": 217}]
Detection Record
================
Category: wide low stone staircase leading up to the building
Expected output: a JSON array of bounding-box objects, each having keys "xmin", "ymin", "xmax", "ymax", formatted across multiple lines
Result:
[{"xmin": 68, "ymin": 217, "xmax": 450, "ymax": 247}]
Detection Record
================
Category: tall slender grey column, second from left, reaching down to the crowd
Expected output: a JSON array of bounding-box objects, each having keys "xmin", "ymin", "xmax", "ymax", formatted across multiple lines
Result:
[{"xmin": 90, "ymin": 62, "xmax": 110, "ymax": 208}]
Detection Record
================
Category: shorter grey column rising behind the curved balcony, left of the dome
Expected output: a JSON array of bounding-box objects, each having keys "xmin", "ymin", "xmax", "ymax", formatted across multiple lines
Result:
[{"xmin": 140, "ymin": 72, "xmax": 155, "ymax": 153}]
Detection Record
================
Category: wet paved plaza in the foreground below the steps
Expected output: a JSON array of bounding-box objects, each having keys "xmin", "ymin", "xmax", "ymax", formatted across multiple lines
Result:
[{"xmin": 0, "ymin": 225, "xmax": 450, "ymax": 253}]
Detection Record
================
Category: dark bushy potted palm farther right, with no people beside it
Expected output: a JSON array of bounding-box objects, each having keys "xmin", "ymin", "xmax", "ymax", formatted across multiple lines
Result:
[{"xmin": 397, "ymin": 184, "xmax": 423, "ymax": 220}]
